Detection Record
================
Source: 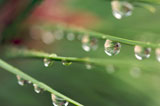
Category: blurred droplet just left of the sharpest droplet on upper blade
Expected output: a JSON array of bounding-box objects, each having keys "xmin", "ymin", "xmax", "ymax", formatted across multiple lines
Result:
[{"xmin": 82, "ymin": 35, "xmax": 98, "ymax": 52}]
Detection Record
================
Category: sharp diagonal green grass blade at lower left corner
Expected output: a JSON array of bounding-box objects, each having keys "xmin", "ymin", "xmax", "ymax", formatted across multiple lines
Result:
[{"xmin": 0, "ymin": 59, "xmax": 83, "ymax": 106}]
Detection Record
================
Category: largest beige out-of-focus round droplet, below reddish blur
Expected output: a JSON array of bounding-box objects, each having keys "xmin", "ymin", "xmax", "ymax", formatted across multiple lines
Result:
[{"xmin": 41, "ymin": 31, "xmax": 55, "ymax": 44}]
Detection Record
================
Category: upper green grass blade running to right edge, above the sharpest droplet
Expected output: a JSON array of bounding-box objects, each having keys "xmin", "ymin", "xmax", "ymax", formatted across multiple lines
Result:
[{"xmin": 41, "ymin": 25, "xmax": 160, "ymax": 48}]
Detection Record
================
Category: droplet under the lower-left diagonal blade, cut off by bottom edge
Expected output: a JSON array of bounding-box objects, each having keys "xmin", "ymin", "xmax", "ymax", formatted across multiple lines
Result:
[{"xmin": 51, "ymin": 94, "xmax": 69, "ymax": 106}]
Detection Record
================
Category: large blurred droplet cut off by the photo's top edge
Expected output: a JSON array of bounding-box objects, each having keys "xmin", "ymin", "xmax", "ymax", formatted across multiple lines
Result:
[{"xmin": 111, "ymin": 0, "xmax": 133, "ymax": 19}]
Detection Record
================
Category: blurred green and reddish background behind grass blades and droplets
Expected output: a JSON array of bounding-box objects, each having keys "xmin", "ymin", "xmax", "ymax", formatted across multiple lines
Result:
[{"xmin": 0, "ymin": 0, "xmax": 160, "ymax": 106}]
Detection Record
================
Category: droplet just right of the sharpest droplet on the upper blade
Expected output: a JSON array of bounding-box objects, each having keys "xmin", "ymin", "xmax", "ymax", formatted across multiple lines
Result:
[{"xmin": 134, "ymin": 45, "xmax": 151, "ymax": 60}]
